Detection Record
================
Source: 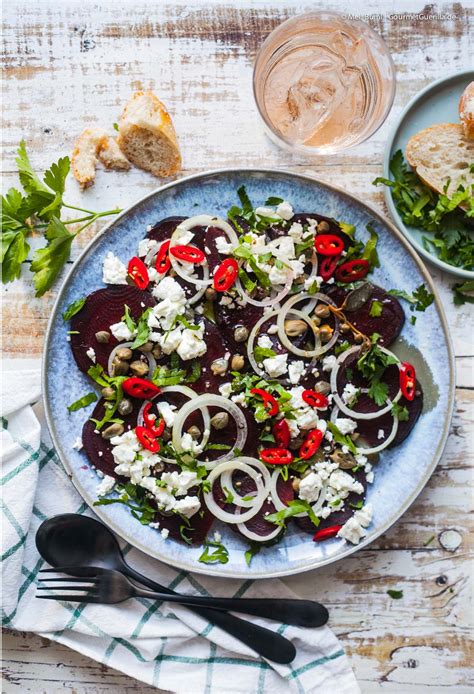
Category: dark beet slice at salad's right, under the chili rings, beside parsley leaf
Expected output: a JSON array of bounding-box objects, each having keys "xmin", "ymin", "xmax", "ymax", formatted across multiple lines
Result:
[{"xmin": 325, "ymin": 285, "xmax": 405, "ymax": 347}]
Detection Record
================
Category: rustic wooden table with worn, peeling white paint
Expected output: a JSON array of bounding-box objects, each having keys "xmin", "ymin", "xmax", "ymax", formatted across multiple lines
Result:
[{"xmin": 2, "ymin": 0, "xmax": 474, "ymax": 694}]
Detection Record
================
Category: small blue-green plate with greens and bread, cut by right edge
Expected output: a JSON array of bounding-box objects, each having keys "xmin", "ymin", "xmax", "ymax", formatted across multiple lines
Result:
[{"xmin": 383, "ymin": 70, "xmax": 474, "ymax": 280}]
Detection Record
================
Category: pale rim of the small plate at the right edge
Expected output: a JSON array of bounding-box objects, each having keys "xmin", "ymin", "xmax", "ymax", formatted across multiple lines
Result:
[{"xmin": 382, "ymin": 68, "xmax": 474, "ymax": 280}]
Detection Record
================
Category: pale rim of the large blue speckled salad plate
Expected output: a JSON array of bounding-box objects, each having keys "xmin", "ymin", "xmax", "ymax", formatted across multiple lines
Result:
[{"xmin": 41, "ymin": 167, "xmax": 456, "ymax": 580}]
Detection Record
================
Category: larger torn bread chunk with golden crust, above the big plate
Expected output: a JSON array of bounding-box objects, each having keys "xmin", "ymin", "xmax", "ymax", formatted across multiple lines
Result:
[{"xmin": 118, "ymin": 91, "xmax": 181, "ymax": 177}]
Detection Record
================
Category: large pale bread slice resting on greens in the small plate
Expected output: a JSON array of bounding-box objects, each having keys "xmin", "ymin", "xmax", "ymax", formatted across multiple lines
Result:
[{"xmin": 406, "ymin": 123, "xmax": 474, "ymax": 195}]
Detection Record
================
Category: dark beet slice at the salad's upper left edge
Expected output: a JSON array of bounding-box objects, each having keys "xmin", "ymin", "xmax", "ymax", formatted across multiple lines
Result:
[{"xmin": 71, "ymin": 285, "xmax": 156, "ymax": 373}]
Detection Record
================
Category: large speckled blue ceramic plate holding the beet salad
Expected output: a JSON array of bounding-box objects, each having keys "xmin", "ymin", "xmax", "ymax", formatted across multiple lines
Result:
[{"xmin": 43, "ymin": 169, "xmax": 454, "ymax": 578}]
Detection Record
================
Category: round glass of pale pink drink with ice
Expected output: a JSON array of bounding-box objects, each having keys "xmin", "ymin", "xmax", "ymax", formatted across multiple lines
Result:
[{"xmin": 253, "ymin": 12, "xmax": 395, "ymax": 155}]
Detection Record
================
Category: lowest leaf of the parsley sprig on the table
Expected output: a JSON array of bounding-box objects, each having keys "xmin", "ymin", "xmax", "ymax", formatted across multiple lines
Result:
[{"xmin": 31, "ymin": 217, "xmax": 75, "ymax": 296}]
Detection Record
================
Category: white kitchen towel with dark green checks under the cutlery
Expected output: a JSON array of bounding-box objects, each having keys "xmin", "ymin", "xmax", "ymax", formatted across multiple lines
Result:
[{"xmin": 1, "ymin": 362, "xmax": 360, "ymax": 694}]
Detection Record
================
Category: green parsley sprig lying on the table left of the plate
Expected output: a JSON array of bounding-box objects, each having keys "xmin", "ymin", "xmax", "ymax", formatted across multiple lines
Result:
[{"xmin": 1, "ymin": 140, "xmax": 121, "ymax": 296}]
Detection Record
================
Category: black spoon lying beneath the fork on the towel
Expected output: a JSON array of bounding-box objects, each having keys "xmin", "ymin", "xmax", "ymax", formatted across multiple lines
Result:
[{"xmin": 36, "ymin": 513, "xmax": 316, "ymax": 663}]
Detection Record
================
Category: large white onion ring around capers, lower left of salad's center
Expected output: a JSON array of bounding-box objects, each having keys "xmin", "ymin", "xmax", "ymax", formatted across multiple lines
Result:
[{"xmin": 172, "ymin": 393, "xmax": 248, "ymax": 470}]
